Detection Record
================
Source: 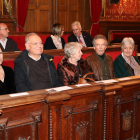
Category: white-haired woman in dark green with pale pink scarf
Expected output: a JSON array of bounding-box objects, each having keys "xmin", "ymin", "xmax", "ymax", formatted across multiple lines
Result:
[{"xmin": 114, "ymin": 37, "xmax": 140, "ymax": 78}]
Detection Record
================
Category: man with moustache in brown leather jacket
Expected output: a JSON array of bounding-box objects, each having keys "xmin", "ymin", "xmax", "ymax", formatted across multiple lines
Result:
[{"xmin": 86, "ymin": 35, "xmax": 115, "ymax": 81}]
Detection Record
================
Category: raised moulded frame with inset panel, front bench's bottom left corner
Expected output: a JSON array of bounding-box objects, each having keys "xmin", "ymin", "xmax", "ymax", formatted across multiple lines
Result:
[{"xmin": 0, "ymin": 111, "xmax": 42, "ymax": 140}]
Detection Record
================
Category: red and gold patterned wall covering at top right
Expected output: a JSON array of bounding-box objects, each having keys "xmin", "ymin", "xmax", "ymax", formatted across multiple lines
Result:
[{"xmin": 105, "ymin": 0, "xmax": 140, "ymax": 21}]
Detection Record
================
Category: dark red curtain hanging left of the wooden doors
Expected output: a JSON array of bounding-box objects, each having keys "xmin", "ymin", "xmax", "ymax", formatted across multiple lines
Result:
[{"xmin": 17, "ymin": 0, "xmax": 29, "ymax": 31}]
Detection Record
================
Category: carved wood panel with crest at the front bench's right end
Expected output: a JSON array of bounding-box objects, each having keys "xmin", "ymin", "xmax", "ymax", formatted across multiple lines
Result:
[{"xmin": 114, "ymin": 90, "xmax": 140, "ymax": 140}]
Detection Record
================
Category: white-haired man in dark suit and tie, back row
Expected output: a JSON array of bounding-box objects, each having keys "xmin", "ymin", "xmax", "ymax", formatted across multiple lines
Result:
[{"xmin": 68, "ymin": 21, "xmax": 93, "ymax": 47}]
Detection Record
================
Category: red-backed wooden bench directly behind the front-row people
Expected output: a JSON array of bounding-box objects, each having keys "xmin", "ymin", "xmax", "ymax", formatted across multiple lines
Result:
[{"xmin": 3, "ymin": 45, "xmax": 137, "ymax": 69}]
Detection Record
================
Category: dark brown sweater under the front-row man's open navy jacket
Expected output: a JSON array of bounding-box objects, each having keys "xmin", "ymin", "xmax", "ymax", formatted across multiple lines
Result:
[{"xmin": 26, "ymin": 57, "xmax": 52, "ymax": 90}]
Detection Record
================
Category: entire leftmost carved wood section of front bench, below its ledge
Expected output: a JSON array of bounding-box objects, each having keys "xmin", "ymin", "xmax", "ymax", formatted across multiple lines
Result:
[{"xmin": 0, "ymin": 101, "xmax": 48, "ymax": 140}]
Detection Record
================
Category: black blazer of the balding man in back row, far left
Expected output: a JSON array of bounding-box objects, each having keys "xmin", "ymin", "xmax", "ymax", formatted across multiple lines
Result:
[{"xmin": 0, "ymin": 38, "xmax": 20, "ymax": 52}]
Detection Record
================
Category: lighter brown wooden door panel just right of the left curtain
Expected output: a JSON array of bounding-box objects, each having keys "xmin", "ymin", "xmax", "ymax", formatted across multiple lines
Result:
[{"xmin": 24, "ymin": 0, "xmax": 52, "ymax": 32}]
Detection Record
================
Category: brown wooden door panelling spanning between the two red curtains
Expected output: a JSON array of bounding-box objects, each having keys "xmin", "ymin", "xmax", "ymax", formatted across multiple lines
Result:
[{"xmin": 24, "ymin": 0, "xmax": 91, "ymax": 32}]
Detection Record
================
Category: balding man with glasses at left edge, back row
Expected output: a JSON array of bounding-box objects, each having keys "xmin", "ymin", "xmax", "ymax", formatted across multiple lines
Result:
[{"xmin": 0, "ymin": 23, "xmax": 19, "ymax": 52}]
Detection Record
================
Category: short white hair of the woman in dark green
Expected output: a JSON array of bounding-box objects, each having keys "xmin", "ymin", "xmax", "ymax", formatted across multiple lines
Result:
[{"xmin": 121, "ymin": 37, "xmax": 135, "ymax": 49}]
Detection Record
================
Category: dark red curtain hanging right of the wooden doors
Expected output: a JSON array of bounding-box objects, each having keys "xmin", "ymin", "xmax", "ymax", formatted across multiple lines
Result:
[{"xmin": 90, "ymin": 0, "xmax": 102, "ymax": 38}]
